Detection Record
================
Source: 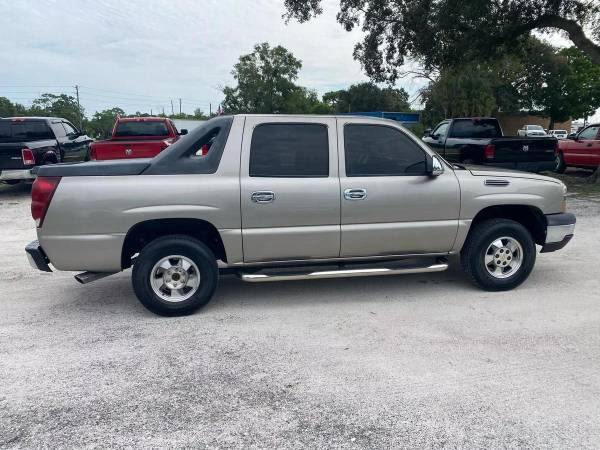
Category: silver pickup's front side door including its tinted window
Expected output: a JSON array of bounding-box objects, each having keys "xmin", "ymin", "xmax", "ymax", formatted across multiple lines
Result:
[{"xmin": 338, "ymin": 118, "xmax": 460, "ymax": 257}]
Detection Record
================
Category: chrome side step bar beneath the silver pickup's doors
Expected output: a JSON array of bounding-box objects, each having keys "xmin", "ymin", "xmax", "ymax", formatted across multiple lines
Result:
[{"xmin": 239, "ymin": 261, "xmax": 448, "ymax": 283}]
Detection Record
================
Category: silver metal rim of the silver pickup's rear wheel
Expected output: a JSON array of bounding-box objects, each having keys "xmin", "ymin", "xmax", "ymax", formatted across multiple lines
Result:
[{"xmin": 150, "ymin": 255, "xmax": 200, "ymax": 303}]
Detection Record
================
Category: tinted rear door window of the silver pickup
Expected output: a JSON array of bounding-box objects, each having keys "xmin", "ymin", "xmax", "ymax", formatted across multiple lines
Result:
[{"xmin": 250, "ymin": 123, "xmax": 329, "ymax": 178}]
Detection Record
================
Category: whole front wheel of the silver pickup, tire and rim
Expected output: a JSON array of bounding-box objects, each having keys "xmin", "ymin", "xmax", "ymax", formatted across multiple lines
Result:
[{"xmin": 460, "ymin": 219, "xmax": 536, "ymax": 291}]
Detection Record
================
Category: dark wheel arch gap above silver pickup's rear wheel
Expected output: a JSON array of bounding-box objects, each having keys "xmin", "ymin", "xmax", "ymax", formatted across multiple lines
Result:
[{"xmin": 121, "ymin": 218, "xmax": 227, "ymax": 269}]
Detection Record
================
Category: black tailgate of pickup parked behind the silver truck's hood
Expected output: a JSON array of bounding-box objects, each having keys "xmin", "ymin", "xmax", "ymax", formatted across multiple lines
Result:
[{"xmin": 491, "ymin": 137, "xmax": 558, "ymax": 162}]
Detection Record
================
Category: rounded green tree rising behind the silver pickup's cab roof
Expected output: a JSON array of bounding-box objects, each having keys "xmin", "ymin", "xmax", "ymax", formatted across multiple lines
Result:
[{"xmin": 223, "ymin": 42, "xmax": 302, "ymax": 113}]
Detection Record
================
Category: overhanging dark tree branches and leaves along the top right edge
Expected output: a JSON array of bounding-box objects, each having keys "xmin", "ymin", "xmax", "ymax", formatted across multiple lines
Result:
[{"xmin": 284, "ymin": 0, "xmax": 600, "ymax": 81}]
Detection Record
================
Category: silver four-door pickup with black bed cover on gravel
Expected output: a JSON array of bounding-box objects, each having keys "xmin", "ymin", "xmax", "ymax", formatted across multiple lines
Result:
[{"xmin": 26, "ymin": 115, "xmax": 575, "ymax": 315}]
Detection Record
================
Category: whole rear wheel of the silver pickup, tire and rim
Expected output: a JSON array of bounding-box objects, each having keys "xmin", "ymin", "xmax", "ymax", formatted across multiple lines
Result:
[{"xmin": 132, "ymin": 235, "xmax": 219, "ymax": 316}]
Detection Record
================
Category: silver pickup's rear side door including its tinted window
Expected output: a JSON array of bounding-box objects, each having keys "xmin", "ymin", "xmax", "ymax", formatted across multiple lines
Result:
[{"xmin": 240, "ymin": 116, "xmax": 340, "ymax": 262}]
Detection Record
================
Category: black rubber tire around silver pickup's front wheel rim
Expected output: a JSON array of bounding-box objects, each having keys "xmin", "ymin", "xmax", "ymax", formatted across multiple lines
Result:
[{"xmin": 460, "ymin": 219, "xmax": 536, "ymax": 291}]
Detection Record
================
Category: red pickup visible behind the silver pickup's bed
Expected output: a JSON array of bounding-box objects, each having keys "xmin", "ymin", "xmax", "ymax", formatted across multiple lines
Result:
[{"xmin": 90, "ymin": 117, "xmax": 187, "ymax": 160}]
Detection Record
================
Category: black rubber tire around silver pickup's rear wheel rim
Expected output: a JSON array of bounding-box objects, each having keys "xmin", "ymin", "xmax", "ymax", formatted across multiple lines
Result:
[{"xmin": 131, "ymin": 235, "xmax": 219, "ymax": 316}]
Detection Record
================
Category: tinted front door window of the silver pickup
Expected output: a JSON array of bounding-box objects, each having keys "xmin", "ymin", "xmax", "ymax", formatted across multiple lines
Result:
[{"xmin": 344, "ymin": 124, "xmax": 426, "ymax": 177}]
